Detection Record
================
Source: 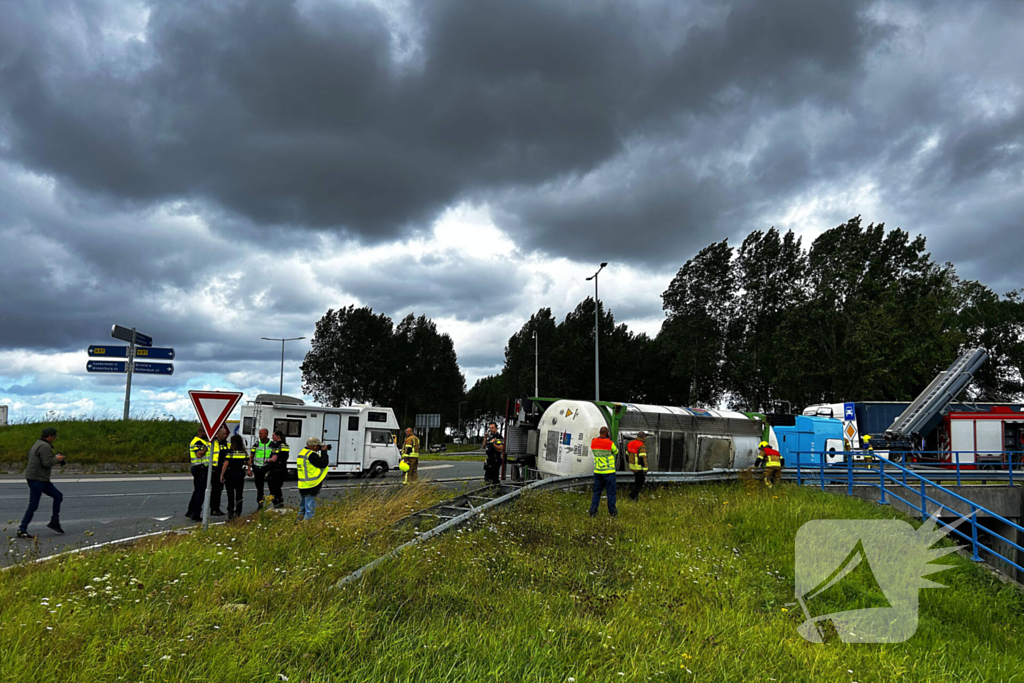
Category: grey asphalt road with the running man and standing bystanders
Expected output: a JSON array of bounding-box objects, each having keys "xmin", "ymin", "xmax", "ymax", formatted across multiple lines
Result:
[{"xmin": 0, "ymin": 461, "xmax": 483, "ymax": 566}]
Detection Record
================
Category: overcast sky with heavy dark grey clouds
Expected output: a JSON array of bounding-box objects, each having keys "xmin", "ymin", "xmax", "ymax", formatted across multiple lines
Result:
[{"xmin": 0, "ymin": 0, "xmax": 1024, "ymax": 419}]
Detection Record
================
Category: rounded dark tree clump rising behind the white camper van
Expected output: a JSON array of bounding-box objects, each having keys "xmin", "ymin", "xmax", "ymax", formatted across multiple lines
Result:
[{"xmin": 301, "ymin": 306, "xmax": 466, "ymax": 436}]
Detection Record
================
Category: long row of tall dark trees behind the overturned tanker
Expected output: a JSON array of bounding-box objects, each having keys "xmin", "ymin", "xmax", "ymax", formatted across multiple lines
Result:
[{"xmin": 468, "ymin": 217, "xmax": 1024, "ymax": 415}]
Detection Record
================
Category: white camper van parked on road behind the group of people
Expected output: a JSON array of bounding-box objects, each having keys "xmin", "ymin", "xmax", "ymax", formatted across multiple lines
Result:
[{"xmin": 241, "ymin": 393, "xmax": 398, "ymax": 476}]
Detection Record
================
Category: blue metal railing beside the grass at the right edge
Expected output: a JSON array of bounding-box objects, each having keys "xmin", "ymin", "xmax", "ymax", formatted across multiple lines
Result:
[{"xmin": 786, "ymin": 451, "xmax": 1024, "ymax": 572}]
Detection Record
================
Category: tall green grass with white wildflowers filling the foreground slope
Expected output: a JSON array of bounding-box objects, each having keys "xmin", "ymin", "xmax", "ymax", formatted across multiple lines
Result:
[{"xmin": 0, "ymin": 484, "xmax": 1024, "ymax": 683}]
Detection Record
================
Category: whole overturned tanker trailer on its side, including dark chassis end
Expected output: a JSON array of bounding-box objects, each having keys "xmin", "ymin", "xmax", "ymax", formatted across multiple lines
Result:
[{"xmin": 505, "ymin": 398, "xmax": 777, "ymax": 479}]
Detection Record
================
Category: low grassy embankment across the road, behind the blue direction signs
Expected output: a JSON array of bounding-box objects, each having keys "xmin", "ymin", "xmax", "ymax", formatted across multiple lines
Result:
[{"xmin": 0, "ymin": 420, "xmax": 199, "ymax": 465}]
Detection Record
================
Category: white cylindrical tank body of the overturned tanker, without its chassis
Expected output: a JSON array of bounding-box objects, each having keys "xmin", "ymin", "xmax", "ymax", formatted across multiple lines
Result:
[{"xmin": 537, "ymin": 399, "xmax": 774, "ymax": 476}]
